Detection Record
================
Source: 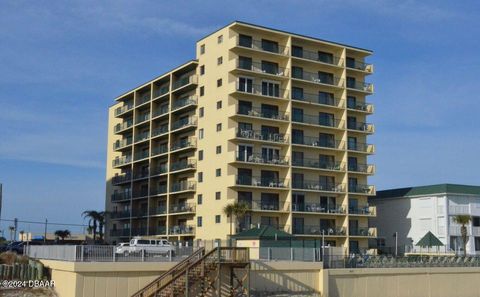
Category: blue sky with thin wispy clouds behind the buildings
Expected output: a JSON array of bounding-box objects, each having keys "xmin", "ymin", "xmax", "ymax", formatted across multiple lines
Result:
[{"xmin": 0, "ymin": 0, "xmax": 480, "ymax": 235}]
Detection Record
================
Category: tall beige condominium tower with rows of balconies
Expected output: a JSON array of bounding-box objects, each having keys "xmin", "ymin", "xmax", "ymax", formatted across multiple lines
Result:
[{"xmin": 106, "ymin": 22, "xmax": 376, "ymax": 251}]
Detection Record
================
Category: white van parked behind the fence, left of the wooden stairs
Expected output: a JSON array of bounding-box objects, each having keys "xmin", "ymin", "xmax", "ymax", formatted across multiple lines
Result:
[{"xmin": 115, "ymin": 237, "xmax": 175, "ymax": 256}]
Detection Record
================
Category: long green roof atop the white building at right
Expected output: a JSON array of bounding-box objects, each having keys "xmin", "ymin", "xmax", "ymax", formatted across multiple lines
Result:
[{"xmin": 375, "ymin": 184, "xmax": 480, "ymax": 198}]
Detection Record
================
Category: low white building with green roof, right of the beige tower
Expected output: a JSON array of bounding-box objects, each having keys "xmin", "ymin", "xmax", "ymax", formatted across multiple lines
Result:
[{"xmin": 370, "ymin": 184, "xmax": 480, "ymax": 255}]
